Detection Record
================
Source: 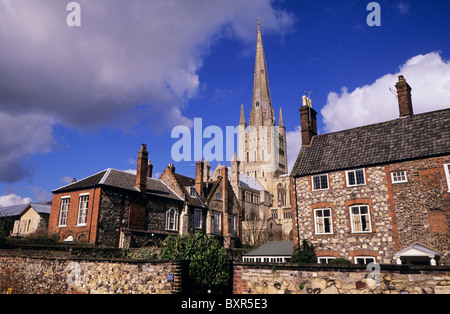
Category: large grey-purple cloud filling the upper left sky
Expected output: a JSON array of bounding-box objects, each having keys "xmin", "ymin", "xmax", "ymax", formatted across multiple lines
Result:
[{"xmin": 0, "ymin": 0, "xmax": 293, "ymax": 182}]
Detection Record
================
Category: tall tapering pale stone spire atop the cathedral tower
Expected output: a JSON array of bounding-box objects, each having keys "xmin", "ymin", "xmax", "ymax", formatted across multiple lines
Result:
[{"xmin": 250, "ymin": 20, "xmax": 275, "ymax": 126}]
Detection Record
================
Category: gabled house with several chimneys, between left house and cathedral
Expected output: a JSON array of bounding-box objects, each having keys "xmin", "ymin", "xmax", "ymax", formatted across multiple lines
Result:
[{"xmin": 160, "ymin": 160, "xmax": 242, "ymax": 247}]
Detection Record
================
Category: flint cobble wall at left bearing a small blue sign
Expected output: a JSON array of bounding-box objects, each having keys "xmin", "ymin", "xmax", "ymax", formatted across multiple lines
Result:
[{"xmin": 0, "ymin": 255, "xmax": 189, "ymax": 294}]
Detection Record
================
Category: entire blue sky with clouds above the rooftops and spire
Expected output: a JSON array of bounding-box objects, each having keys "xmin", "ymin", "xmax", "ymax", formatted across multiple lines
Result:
[{"xmin": 0, "ymin": 0, "xmax": 450, "ymax": 206}]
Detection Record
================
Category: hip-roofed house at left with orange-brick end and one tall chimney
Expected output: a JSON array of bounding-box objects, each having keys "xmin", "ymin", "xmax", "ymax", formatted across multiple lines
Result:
[{"xmin": 48, "ymin": 145, "xmax": 184, "ymax": 247}]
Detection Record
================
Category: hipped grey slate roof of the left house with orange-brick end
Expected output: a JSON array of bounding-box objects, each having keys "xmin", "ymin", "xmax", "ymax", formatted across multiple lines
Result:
[{"xmin": 52, "ymin": 169, "xmax": 182, "ymax": 201}]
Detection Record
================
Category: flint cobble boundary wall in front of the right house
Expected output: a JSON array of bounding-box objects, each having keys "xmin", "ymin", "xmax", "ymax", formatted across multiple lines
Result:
[{"xmin": 233, "ymin": 263, "xmax": 450, "ymax": 294}]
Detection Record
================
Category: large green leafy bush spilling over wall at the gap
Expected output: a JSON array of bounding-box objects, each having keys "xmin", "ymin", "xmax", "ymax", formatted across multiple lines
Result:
[{"xmin": 160, "ymin": 234, "xmax": 230, "ymax": 286}]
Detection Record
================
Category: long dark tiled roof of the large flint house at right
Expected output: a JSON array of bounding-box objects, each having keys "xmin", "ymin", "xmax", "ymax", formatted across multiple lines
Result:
[{"xmin": 291, "ymin": 109, "xmax": 450, "ymax": 177}]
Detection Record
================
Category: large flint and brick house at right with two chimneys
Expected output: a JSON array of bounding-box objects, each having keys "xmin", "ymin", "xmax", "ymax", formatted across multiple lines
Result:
[{"xmin": 291, "ymin": 76, "xmax": 450, "ymax": 265}]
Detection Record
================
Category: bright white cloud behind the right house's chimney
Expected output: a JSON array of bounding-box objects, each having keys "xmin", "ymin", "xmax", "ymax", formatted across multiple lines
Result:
[{"xmin": 321, "ymin": 52, "xmax": 450, "ymax": 132}]
